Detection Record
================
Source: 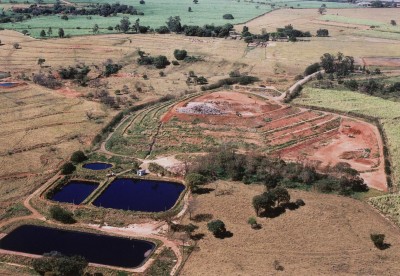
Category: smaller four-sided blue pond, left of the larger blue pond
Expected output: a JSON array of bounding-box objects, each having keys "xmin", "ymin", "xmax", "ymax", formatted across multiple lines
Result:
[{"xmin": 51, "ymin": 181, "xmax": 99, "ymax": 204}]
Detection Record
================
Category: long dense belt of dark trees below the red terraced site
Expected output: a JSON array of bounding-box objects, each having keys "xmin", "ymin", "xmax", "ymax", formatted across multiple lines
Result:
[{"xmin": 186, "ymin": 145, "xmax": 368, "ymax": 195}]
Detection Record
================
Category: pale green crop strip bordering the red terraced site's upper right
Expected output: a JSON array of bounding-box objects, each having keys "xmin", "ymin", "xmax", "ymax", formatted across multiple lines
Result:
[{"xmin": 294, "ymin": 87, "xmax": 400, "ymax": 186}]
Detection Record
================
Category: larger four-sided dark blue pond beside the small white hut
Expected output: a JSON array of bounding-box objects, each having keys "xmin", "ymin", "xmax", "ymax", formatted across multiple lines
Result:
[{"xmin": 93, "ymin": 178, "xmax": 185, "ymax": 212}]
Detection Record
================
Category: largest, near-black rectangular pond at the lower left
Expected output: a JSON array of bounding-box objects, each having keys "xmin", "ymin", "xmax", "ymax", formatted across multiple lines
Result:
[{"xmin": 0, "ymin": 225, "xmax": 155, "ymax": 268}]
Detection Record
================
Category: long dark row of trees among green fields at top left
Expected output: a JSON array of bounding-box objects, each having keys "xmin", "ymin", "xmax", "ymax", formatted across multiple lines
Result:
[{"xmin": 14, "ymin": 1, "xmax": 143, "ymax": 20}]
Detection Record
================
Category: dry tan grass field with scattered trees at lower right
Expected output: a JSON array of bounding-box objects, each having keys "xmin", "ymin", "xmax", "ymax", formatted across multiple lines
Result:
[{"xmin": 182, "ymin": 182, "xmax": 400, "ymax": 275}]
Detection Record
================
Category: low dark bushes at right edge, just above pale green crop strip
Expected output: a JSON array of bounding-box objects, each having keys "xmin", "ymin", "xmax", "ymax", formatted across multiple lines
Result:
[{"xmin": 343, "ymin": 79, "xmax": 400, "ymax": 95}]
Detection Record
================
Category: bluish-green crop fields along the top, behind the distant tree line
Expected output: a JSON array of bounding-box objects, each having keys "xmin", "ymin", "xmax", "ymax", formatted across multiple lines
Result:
[{"xmin": 0, "ymin": 0, "xmax": 354, "ymax": 37}]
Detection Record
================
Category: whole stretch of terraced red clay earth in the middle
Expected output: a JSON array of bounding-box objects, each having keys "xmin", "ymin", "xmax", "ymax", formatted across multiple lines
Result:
[{"xmin": 160, "ymin": 91, "xmax": 387, "ymax": 191}]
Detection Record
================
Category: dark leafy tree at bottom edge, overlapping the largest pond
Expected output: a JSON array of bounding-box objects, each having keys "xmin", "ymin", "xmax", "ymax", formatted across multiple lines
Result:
[{"xmin": 32, "ymin": 252, "xmax": 88, "ymax": 276}]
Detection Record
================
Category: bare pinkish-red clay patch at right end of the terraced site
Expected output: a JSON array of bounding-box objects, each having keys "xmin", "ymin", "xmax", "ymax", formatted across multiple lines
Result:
[{"xmin": 279, "ymin": 118, "xmax": 387, "ymax": 191}]
